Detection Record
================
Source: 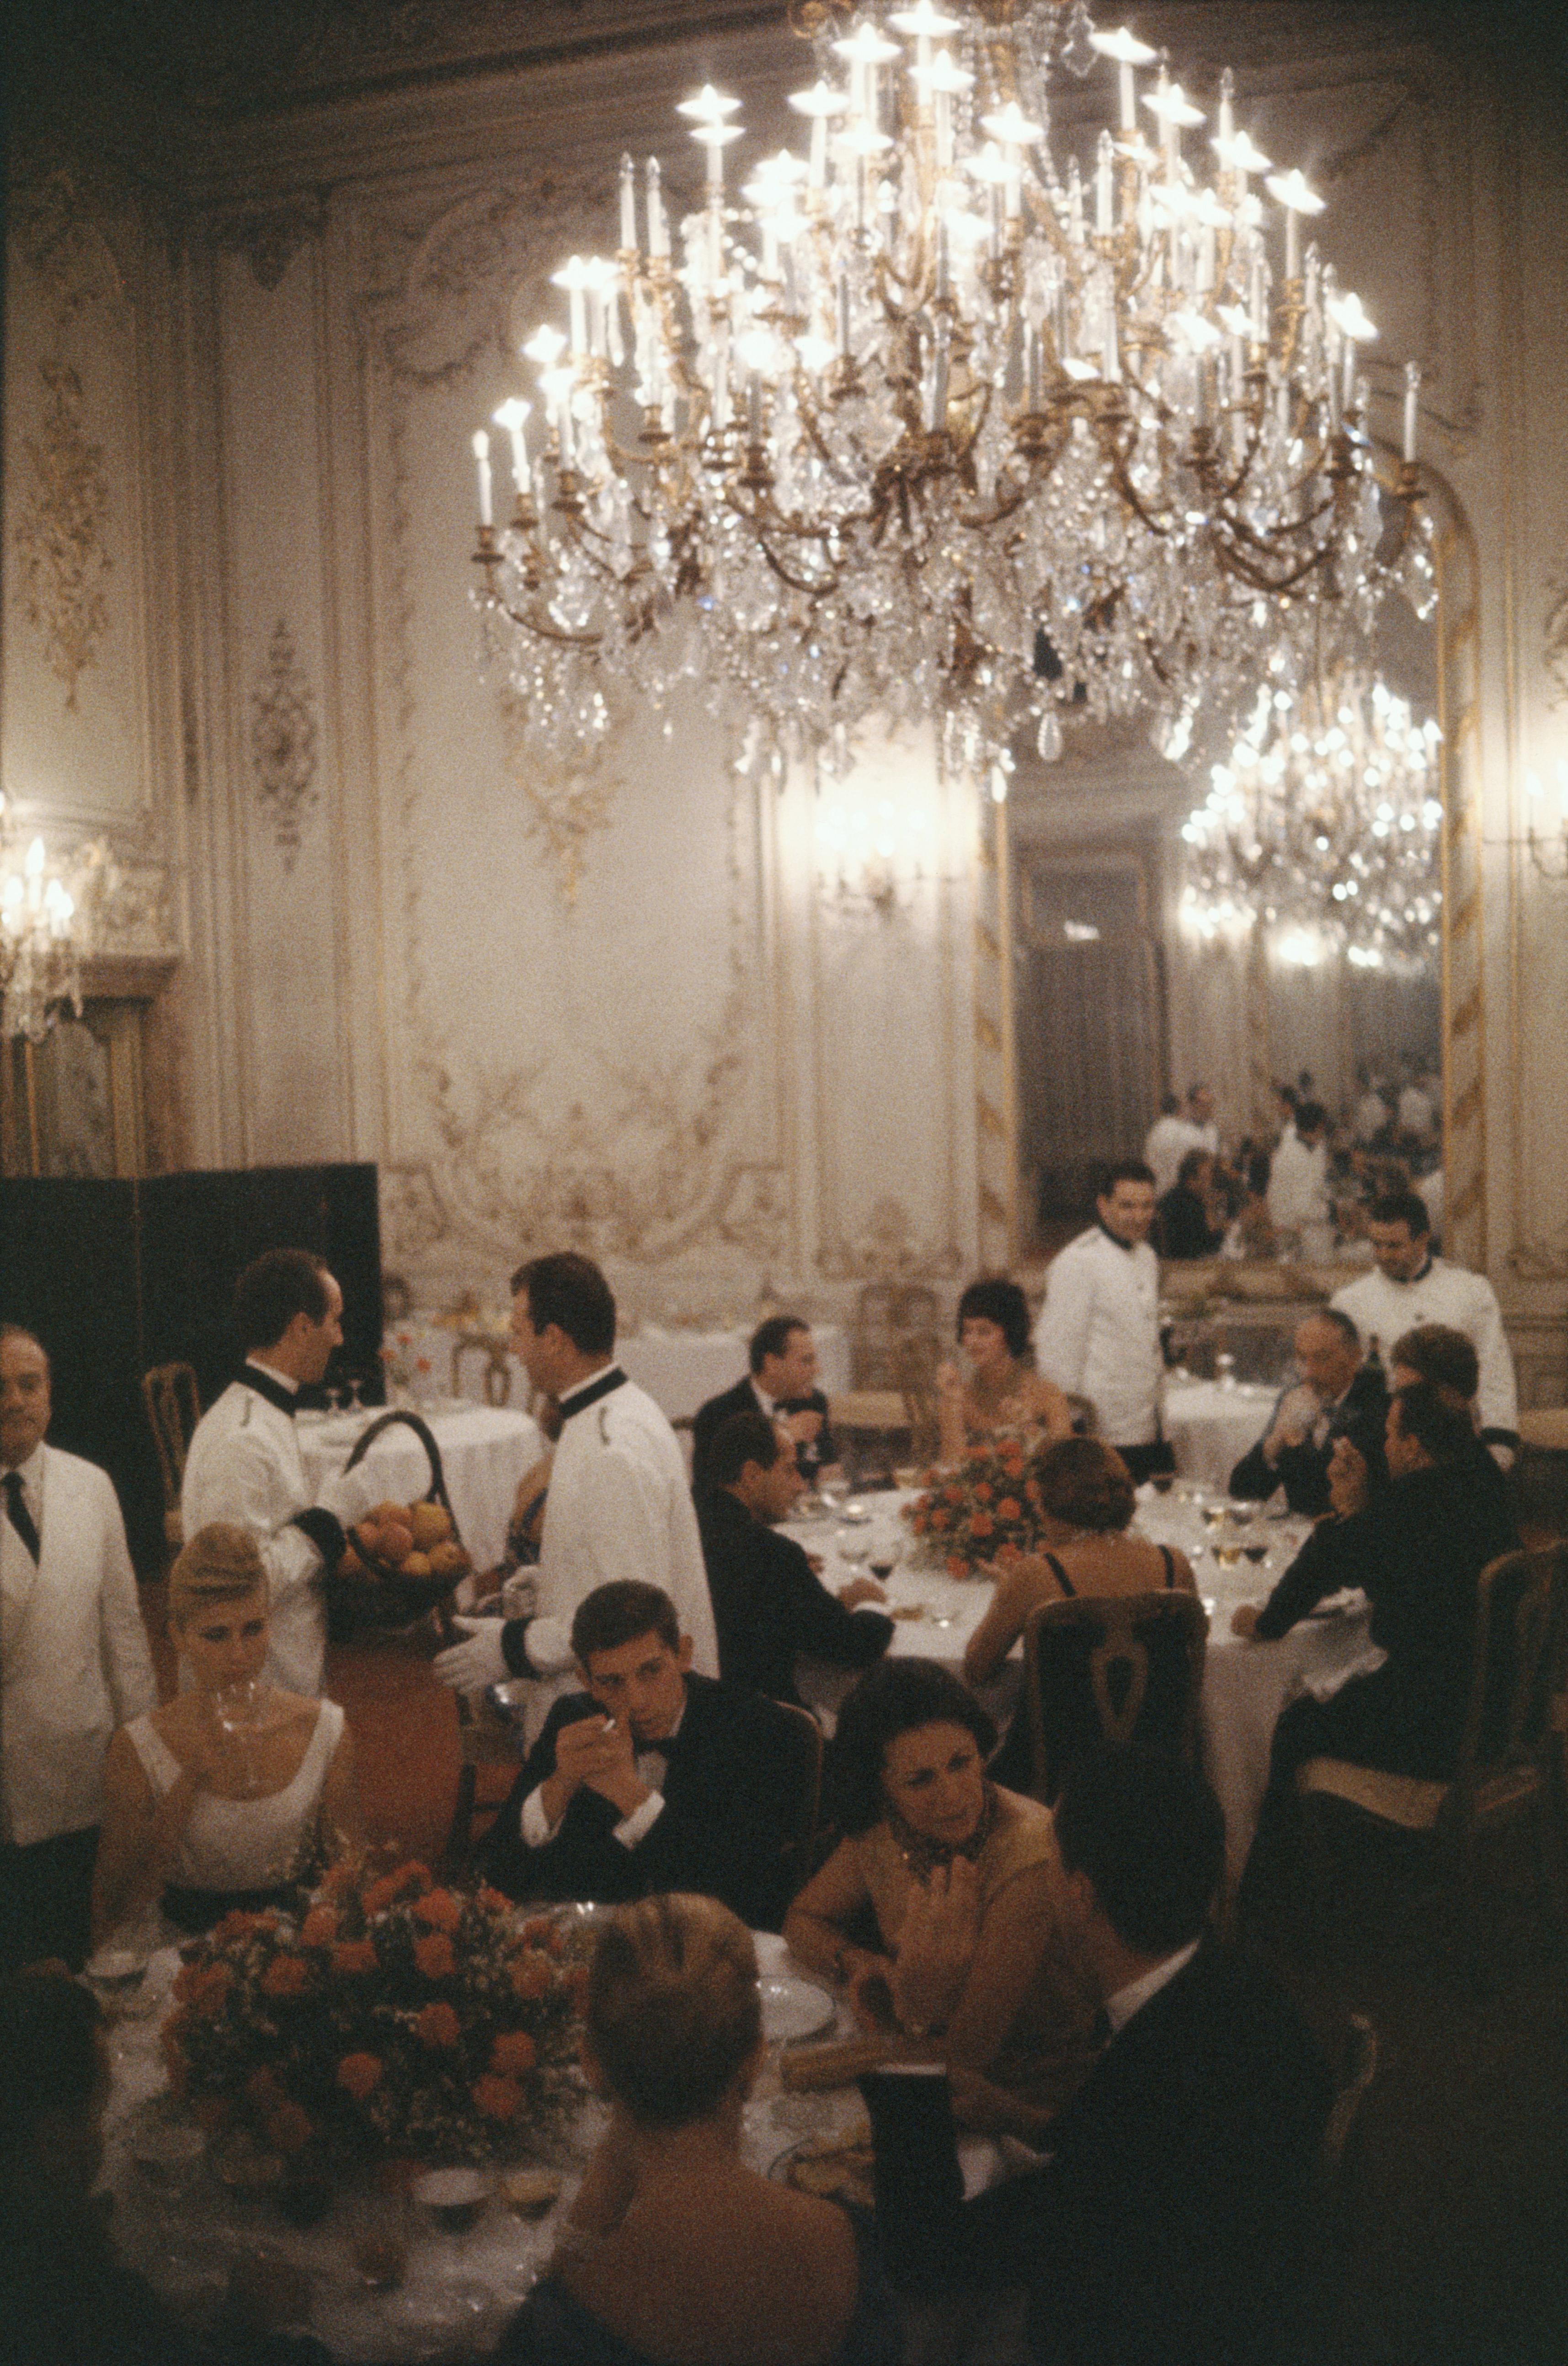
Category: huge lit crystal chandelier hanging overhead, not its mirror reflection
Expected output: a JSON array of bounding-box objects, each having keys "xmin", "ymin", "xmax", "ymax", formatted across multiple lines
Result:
[{"xmin": 473, "ymin": 0, "xmax": 1431, "ymax": 774}]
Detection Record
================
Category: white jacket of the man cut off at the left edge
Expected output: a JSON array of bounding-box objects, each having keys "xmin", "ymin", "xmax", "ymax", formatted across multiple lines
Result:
[{"xmin": 0, "ymin": 1445, "xmax": 159, "ymax": 1843}]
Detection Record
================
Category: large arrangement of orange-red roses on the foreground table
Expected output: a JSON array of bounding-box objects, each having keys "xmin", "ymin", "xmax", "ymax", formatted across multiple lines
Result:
[{"xmin": 161, "ymin": 1864, "xmax": 587, "ymax": 2163}]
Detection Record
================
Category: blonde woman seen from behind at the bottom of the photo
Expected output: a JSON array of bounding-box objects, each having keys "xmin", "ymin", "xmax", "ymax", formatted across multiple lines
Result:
[{"xmin": 496, "ymin": 1895, "xmax": 899, "ymax": 2366}]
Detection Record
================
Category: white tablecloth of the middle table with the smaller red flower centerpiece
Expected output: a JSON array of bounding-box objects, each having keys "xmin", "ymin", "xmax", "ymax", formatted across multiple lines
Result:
[{"xmin": 788, "ymin": 1488, "xmax": 1369, "ymax": 1886}]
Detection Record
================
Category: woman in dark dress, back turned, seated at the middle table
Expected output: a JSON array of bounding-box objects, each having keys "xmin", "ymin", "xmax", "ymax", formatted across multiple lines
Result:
[{"xmin": 963, "ymin": 1439, "xmax": 1197, "ymax": 1685}]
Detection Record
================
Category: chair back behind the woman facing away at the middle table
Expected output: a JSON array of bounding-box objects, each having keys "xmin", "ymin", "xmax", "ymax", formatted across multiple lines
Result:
[{"xmin": 1019, "ymin": 1590, "xmax": 1209, "ymax": 1805}]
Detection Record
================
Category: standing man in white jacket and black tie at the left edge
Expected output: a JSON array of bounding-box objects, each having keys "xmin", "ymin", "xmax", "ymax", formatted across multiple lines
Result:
[{"xmin": 0, "ymin": 1322, "xmax": 159, "ymax": 1971}]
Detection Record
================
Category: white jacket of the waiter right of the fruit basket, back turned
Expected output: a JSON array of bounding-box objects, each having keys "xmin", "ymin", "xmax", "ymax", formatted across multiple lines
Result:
[{"xmin": 525, "ymin": 1372, "xmax": 719, "ymax": 1749}]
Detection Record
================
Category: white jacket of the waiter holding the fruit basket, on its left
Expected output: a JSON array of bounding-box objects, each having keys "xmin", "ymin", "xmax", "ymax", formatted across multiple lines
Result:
[{"xmin": 180, "ymin": 1365, "xmax": 371, "ymax": 1697}]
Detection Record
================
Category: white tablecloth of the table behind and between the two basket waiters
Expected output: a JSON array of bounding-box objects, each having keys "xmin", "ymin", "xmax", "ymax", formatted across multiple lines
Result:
[{"xmin": 300, "ymin": 1405, "xmax": 544, "ymax": 1568}]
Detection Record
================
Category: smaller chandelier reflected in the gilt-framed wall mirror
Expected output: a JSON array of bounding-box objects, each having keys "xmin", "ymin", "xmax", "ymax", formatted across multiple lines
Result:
[{"xmin": 1180, "ymin": 674, "xmax": 1443, "ymax": 970}]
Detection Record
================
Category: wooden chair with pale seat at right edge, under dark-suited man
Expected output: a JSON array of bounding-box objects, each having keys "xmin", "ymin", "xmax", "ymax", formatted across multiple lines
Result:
[{"xmin": 1296, "ymin": 1542, "xmax": 1568, "ymax": 1990}]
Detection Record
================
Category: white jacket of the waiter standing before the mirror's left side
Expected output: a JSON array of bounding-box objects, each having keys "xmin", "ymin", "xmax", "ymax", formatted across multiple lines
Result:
[{"xmin": 1034, "ymin": 1223, "xmax": 1163, "ymax": 1445}]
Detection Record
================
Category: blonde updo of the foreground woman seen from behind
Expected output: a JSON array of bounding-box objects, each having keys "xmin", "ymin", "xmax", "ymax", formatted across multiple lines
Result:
[{"xmin": 584, "ymin": 1893, "xmax": 762, "ymax": 2127}]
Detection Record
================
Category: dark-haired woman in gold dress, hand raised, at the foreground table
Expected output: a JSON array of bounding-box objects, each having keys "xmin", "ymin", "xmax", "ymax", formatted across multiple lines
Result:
[{"xmin": 785, "ymin": 1659, "xmax": 1090, "ymax": 2132}]
